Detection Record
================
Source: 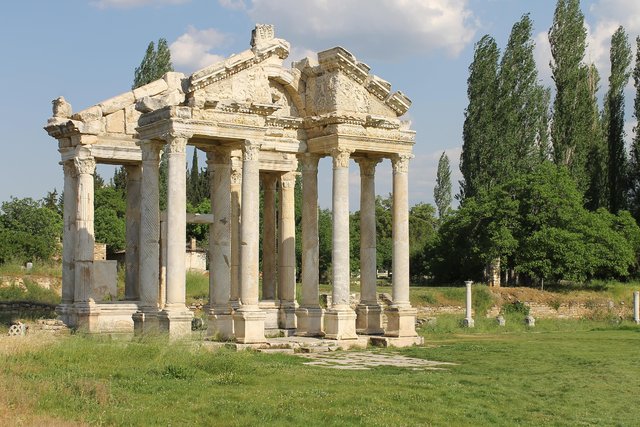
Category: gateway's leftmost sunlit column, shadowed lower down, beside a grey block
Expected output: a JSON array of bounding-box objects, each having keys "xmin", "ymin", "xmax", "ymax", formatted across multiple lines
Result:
[{"xmin": 73, "ymin": 157, "xmax": 98, "ymax": 332}]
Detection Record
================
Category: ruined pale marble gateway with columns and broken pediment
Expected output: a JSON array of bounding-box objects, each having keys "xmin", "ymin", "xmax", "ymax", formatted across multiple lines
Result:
[{"xmin": 45, "ymin": 25, "xmax": 418, "ymax": 344}]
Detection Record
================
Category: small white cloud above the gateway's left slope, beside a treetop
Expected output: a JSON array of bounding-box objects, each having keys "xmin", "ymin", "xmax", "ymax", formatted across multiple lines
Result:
[{"xmin": 169, "ymin": 26, "xmax": 227, "ymax": 72}]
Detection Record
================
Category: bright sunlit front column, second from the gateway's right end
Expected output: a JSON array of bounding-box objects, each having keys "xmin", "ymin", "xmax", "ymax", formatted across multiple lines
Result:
[{"xmin": 324, "ymin": 148, "xmax": 357, "ymax": 340}]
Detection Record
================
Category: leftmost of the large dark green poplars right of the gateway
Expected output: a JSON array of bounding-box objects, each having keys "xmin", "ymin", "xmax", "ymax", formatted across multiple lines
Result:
[{"xmin": 460, "ymin": 35, "xmax": 502, "ymax": 201}]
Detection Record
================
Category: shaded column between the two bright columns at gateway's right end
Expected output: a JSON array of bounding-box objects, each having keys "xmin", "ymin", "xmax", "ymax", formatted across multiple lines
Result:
[{"xmin": 356, "ymin": 157, "xmax": 384, "ymax": 335}]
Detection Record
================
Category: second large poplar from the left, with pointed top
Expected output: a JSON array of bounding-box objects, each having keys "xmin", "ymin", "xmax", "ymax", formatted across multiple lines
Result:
[{"xmin": 496, "ymin": 14, "xmax": 550, "ymax": 179}]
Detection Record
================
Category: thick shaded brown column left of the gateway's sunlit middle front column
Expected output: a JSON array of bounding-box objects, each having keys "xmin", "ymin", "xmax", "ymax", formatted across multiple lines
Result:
[{"xmin": 207, "ymin": 149, "xmax": 234, "ymax": 339}]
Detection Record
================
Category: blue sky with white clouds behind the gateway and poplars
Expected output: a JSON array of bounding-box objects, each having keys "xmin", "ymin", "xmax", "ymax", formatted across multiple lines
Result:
[{"xmin": 0, "ymin": 0, "xmax": 640, "ymax": 210}]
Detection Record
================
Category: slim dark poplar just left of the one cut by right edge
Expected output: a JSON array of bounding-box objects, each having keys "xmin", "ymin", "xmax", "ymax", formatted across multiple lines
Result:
[{"xmin": 606, "ymin": 26, "xmax": 631, "ymax": 213}]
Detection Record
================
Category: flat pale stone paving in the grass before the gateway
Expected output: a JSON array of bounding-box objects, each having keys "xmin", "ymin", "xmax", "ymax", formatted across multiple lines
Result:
[{"xmin": 297, "ymin": 352, "xmax": 457, "ymax": 371}]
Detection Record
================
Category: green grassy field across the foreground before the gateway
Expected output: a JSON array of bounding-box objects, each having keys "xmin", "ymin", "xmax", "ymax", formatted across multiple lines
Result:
[{"xmin": 0, "ymin": 316, "xmax": 640, "ymax": 426}]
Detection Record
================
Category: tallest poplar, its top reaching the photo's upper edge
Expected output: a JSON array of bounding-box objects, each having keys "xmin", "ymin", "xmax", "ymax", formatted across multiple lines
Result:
[{"xmin": 549, "ymin": 0, "xmax": 591, "ymax": 193}]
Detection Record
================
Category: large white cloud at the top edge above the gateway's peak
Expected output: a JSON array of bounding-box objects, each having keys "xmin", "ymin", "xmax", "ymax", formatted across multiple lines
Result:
[{"xmin": 238, "ymin": 0, "xmax": 478, "ymax": 59}]
